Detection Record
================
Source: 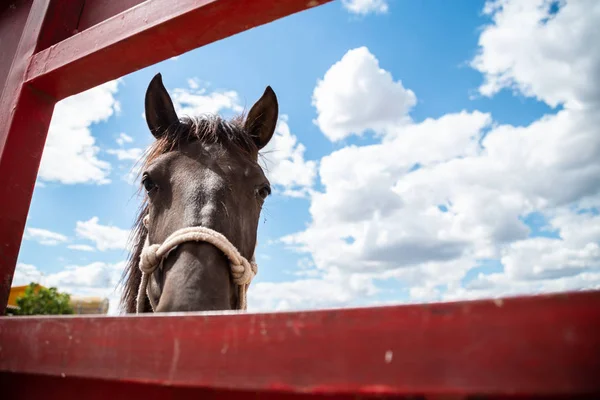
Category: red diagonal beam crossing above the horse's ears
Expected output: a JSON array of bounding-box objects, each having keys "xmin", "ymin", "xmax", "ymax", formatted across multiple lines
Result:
[{"xmin": 27, "ymin": 0, "xmax": 331, "ymax": 100}]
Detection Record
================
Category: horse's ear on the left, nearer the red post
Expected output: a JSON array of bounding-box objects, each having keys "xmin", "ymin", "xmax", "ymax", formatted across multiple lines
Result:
[{"xmin": 145, "ymin": 73, "xmax": 179, "ymax": 139}]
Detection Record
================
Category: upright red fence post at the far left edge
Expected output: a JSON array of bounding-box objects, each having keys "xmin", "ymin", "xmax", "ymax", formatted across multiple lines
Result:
[{"xmin": 0, "ymin": 0, "xmax": 54, "ymax": 315}]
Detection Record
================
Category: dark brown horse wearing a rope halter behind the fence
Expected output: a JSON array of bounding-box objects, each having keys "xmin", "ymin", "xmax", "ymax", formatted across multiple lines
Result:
[{"xmin": 120, "ymin": 73, "xmax": 279, "ymax": 313}]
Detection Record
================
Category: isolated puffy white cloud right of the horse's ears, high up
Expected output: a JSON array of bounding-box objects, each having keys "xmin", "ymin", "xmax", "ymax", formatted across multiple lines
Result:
[{"xmin": 312, "ymin": 47, "xmax": 416, "ymax": 142}]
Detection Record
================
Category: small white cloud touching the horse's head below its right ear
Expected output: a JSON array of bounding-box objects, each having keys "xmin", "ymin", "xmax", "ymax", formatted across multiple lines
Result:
[{"xmin": 261, "ymin": 115, "xmax": 317, "ymax": 197}]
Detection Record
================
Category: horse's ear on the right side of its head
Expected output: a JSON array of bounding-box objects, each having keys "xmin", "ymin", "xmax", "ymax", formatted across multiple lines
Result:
[{"xmin": 244, "ymin": 86, "xmax": 279, "ymax": 150}]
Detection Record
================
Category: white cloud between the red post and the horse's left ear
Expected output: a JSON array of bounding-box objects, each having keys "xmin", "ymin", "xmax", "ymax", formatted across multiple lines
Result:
[{"xmin": 39, "ymin": 80, "xmax": 119, "ymax": 184}]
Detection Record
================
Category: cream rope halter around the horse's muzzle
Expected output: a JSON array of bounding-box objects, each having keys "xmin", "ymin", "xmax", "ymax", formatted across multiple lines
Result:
[{"xmin": 136, "ymin": 215, "xmax": 258, "ymax": 314}]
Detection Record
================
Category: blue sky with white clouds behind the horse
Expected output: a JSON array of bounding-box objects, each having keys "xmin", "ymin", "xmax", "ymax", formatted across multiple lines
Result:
[{"xmin": 15, "ymin": 0, "xmax": 600, "ymax": 310}]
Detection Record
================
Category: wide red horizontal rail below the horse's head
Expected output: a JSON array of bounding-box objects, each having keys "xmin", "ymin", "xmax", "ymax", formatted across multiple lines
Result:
[{"xmin": 0, "ymin": 291, "xmax": 600, "ymax": 396}]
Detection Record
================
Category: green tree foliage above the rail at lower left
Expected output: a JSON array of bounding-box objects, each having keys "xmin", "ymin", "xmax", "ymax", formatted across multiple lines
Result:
[{"xmin": 15, "ymin": 283, "xmax": 73, "ymax": 315}]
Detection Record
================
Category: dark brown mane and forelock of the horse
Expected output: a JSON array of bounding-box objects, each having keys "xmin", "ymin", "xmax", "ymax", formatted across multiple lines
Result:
[{"xmin": 121, "ymin": 115, "xmax": 258, "ymax": 313}]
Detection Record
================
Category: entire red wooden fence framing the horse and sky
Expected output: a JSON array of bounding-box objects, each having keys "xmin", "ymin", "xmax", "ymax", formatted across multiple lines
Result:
[{"xmin": 0, "ymin": 0, "xmax": 600, "ymax": 400}]
